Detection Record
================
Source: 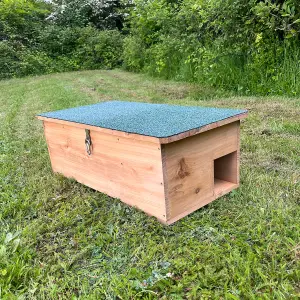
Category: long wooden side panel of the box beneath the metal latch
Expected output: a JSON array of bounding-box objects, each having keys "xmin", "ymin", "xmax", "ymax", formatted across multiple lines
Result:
[{"xmin": 44, "ymin": 121, "xmax": 166, "ymax": 222}]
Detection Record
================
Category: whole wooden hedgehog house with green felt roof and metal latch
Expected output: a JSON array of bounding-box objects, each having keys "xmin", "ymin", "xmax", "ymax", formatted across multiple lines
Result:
[{"xmin": 38, "ymin": 101, "xmax": 247, "ymax": 224}]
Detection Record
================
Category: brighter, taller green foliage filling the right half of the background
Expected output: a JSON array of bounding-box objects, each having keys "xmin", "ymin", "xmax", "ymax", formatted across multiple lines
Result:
[{"xmin": 124, "ymin": 0, "xmax": 300, "ymax": 95}]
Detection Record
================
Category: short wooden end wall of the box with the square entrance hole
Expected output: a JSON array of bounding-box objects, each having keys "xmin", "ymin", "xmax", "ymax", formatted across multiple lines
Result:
[{"xmin": 163, "ymin": 121, "xmax": 239, "ymax": 223}]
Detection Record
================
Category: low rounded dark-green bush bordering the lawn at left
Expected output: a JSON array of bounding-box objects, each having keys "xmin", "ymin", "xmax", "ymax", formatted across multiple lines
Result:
[{"xmin": 0, "ymin": 26, "xmax": 123, "ymax": 79}]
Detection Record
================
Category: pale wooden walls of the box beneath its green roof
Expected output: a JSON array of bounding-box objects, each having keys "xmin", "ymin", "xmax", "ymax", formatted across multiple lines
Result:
[{"xmin": 39, "ymin": 119, "xmax": 240, "ymax": 224}]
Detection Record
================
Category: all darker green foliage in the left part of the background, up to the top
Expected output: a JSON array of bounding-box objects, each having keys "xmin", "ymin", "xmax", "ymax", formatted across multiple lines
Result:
[{"xmin": 0, "ymin": 0, "xmax": 123, "ymax": 79}]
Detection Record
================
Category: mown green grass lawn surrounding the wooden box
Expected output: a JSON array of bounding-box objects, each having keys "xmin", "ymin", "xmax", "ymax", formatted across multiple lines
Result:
[{"xmin": 0, "ymin": 71, "xmax": 300, "ymax": 299}]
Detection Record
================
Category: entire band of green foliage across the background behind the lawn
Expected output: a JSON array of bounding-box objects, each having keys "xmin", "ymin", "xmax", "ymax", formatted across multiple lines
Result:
[{"xmin": 0, "ymin": 0, "xmax": 300, "ymax": 95}]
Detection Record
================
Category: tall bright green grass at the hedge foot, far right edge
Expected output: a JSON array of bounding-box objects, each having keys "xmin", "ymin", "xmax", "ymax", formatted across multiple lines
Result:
[{"xmin": 196, "ymin": 47, "xmax": 300, "ymax": 96}]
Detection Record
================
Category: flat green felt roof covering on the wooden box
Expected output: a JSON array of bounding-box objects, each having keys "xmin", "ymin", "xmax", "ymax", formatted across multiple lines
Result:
[{"xmin": 40, "ymin": 101, "xmax": 247, "ymax": 138}]
